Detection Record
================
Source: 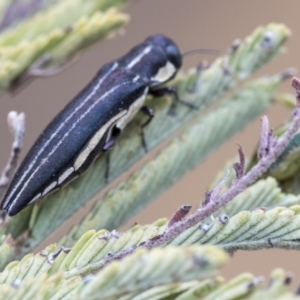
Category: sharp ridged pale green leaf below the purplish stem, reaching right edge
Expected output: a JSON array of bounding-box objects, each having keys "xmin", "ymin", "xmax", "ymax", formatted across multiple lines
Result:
[{"xmin": 171, "ymin": 206, "xmax": 300, "ymax": 252}]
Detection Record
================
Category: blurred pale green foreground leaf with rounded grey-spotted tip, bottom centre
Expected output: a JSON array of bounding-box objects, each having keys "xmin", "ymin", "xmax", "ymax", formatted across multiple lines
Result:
[{"xmin": 81, "ymin": 246, "xmax": 226, "ymax": 299}]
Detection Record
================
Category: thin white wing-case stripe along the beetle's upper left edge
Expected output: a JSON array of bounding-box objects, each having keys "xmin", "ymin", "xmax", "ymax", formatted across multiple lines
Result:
[{"xmin": 3, "ymin": 62, "xmax": 118, "ymax": 206}]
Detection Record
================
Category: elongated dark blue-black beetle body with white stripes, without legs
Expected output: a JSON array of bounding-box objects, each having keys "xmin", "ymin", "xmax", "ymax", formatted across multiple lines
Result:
[{"xmin": 1, "ymin": 35, "xmax": 182, "ymax": 216}]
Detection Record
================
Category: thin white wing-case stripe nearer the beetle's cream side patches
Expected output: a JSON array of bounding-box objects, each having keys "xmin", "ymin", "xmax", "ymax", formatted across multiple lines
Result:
[{"xmin": 10, "ymin": 82, "xmax": 143, "ymax": 210}]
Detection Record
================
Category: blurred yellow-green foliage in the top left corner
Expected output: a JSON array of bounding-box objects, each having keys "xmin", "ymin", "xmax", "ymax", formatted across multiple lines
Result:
[{"xmin": 0, "ymin": 0, "xmax": 128, "ymax": 90}]
